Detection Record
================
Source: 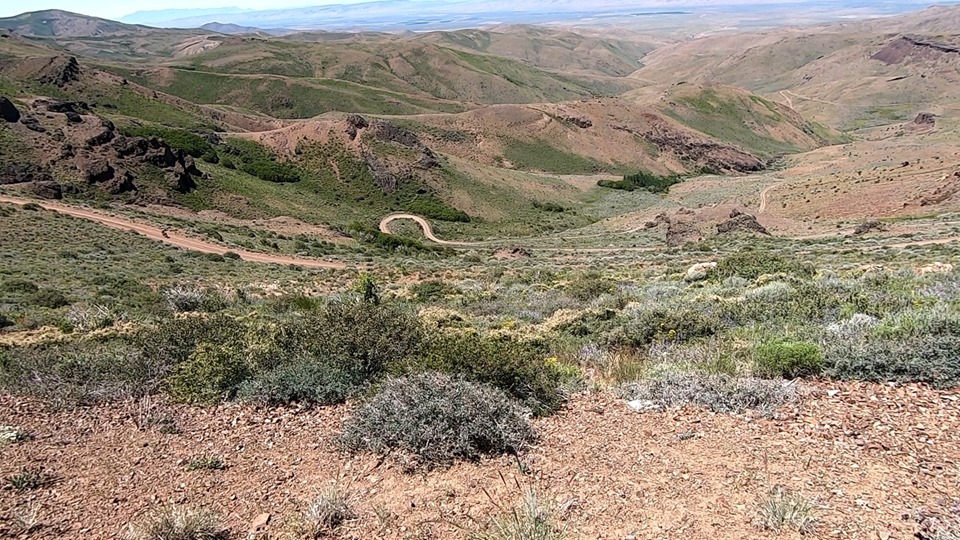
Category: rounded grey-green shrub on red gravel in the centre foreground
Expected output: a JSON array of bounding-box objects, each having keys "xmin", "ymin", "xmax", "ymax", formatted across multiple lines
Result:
[{"xmin": 341, "ymin": 373, "xmax": 534, "ymax": 467}]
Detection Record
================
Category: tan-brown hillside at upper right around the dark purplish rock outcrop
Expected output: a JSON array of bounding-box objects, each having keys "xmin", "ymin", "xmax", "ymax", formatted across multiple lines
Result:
[{"xmin": 631, "ymin": 8, "xmax": 960, "ymax": 128}]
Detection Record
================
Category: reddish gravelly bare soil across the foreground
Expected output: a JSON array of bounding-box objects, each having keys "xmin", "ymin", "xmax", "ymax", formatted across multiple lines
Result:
[{"xmin": 0, "ymin": 382, "xmax": 960, "ymax": 540}]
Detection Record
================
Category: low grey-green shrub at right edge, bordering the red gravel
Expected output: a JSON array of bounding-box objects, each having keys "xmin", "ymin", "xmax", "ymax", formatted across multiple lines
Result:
[{"xmin": 825, "ymin": 334, "xmax": 960, "ymax": 388}]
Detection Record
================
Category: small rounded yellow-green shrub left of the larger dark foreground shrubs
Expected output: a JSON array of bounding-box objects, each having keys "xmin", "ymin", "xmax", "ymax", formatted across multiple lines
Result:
[{"xmin": 166, "ymin": 343, "xmax": 250, "ymax": 403}]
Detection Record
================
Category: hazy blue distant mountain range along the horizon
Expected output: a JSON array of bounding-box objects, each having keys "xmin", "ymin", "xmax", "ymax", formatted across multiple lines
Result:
[{"xmin": 105, "ymin": 0, "xmax": 955, "ymax": 30}]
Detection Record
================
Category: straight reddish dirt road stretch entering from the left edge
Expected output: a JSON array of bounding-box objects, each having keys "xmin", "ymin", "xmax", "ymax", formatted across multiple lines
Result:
[{"xmin": 0, "ymin": 195, "xmax": 347, "ymax": 270}]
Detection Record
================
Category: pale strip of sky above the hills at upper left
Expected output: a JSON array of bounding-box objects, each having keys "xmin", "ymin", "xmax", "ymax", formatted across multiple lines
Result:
[{"xmin": 0, "ymin": 0, "xmax": 369, "ymax": 19}]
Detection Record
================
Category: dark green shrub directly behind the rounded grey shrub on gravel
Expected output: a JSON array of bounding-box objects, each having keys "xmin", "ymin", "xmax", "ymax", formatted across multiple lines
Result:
[{"xmin": 404, "ymin": 334, "xmax": 568, "ymax": 415}]
